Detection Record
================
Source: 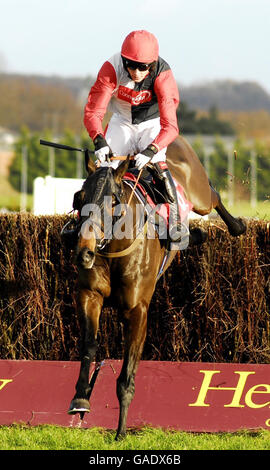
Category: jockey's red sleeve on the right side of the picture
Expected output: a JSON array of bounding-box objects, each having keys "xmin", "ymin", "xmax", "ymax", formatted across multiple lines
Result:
[{"xmin": 153, "ymin": 69, "xmax": 180, "ymax": 150}]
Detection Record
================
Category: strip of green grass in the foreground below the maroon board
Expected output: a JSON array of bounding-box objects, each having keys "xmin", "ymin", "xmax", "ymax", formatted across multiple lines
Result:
[{"xmin": 0, "ymin": 425, "xmax": 270, "ymax": 451}]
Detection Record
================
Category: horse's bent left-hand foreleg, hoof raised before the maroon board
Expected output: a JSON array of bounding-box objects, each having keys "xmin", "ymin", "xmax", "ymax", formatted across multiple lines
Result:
[{"xmin": 69, "ymin": 289, "xmax": 103, "ymax": 414}]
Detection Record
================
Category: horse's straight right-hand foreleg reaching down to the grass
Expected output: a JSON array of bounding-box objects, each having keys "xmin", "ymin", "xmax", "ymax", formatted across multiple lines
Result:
[{"xmin": 116, "ymin": 302, "xmax": 147, "ymax": 439}]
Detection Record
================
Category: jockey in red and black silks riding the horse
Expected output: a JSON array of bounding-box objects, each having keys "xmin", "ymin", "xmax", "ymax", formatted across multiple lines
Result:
[{"xmin": 84, "ymin": 30, "xmax": 181, "ymax": 242}]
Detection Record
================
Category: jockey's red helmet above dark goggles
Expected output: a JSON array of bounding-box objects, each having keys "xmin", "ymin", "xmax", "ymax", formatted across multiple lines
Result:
[{"xmin": 121, "ymin": 30, "xmax": 159, "ymax": 64}]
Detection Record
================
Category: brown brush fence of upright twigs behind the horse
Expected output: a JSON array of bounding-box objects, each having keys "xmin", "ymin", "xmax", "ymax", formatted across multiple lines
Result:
[{"xmin": 0, "ymin": 214, "xmax": 270, "ymax": 363}]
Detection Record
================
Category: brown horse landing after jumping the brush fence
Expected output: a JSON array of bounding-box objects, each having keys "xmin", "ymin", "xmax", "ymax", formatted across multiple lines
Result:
[{"xmin": 66, "ymin": 134, "xmax": 245, "ymax": 438}]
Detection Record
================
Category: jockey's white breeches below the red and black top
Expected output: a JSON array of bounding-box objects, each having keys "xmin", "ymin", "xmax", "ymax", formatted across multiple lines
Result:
[{"xmin": 105, "ymin": 114, "xmax": 167, "ymax": 168}]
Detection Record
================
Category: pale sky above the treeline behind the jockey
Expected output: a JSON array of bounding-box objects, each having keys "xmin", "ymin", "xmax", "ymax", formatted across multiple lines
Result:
[{"xmin": 0, "ymin": 0, "xmax": 270, "ymax": 92}]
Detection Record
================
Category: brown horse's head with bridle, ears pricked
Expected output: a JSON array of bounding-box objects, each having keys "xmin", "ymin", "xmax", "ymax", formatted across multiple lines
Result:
[{"xmin": 73, "ymin": 159, "xmax": 129, "ymax": 269}]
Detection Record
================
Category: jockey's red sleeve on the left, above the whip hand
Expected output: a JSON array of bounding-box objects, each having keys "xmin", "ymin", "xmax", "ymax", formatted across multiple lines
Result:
[{"xmin": 84, "ymin": 61, "xmax": 117, "ymax": 139}]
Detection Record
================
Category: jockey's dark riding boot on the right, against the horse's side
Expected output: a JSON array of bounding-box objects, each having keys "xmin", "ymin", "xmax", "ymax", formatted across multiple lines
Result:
[{"xmin": 153, "ymin": 162, "xmax": 188, "ymax": 243}]
